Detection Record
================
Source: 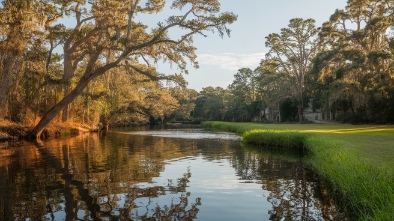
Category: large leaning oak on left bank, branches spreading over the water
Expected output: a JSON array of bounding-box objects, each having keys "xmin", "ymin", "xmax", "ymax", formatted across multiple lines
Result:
[{"xmin": 31, "ymin": 0, "xmax": 236, "ymax": 136}]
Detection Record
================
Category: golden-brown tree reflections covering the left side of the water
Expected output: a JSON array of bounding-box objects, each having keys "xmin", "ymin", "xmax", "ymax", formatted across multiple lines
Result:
[{"xmin": 0, "ymin": 133, "xmax": 200, "ymax": 220}]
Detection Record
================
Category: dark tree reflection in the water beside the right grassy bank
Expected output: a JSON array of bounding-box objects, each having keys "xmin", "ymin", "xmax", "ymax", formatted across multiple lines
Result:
[{"xmin": 231, "ymin": 146, "xmax": 345, "ymax": 220}]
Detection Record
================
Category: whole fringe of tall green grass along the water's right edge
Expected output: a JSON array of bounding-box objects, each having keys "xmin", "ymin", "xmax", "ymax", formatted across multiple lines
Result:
[{"xmin": 204, "ymin": 122, "xmax": 394, "ymax": 221}]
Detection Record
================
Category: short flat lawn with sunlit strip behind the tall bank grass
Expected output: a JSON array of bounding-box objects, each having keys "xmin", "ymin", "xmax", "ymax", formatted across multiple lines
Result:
[{"xmin": 204, "ymin": 122, "xmax": 394, "ymax": 168}]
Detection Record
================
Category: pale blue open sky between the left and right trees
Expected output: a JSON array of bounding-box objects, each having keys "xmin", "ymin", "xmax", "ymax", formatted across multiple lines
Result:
[{"xmin": 149, "ymin": 0, "xmax": 347, "ymax": 92}]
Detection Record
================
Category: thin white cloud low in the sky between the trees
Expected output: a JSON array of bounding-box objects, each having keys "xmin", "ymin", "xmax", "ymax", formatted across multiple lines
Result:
[{"xmin": 198, "ymin": 53, "xmax": 265, "ymax": 71}]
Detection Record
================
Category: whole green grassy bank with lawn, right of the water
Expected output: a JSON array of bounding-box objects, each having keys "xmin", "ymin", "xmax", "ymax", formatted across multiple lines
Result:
[{"xmin": 204, "ymin": 122, "xmax": 394, "ymax": 220}]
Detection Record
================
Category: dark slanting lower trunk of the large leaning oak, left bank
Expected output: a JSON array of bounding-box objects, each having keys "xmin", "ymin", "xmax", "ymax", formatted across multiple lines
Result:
[{"xmin": 30, "ymin": 78, "xmax": 90, "ymax": 138}]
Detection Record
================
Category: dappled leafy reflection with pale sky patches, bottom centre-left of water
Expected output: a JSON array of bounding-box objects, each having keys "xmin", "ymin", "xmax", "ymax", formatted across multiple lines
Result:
[{"xmin": 93, "ymin": 168, "xmax": 201, "ymax": 220}]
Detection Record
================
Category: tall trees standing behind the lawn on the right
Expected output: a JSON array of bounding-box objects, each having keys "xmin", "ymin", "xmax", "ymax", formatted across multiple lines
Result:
[{"xmin": 193, "ymin": 0, "xmax": 394, "ymax": 123}]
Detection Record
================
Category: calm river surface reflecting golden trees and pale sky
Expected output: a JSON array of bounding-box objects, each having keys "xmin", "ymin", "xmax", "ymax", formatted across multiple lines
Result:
[{"xmin": 0, "ymin": 127, "xmax": 344, "ymax": 221}]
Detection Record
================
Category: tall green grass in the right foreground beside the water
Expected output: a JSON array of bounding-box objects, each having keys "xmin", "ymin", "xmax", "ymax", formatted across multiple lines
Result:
[{"xmin": 305, "ymin": 136, "xmax": 394, "ymax": 220}]
